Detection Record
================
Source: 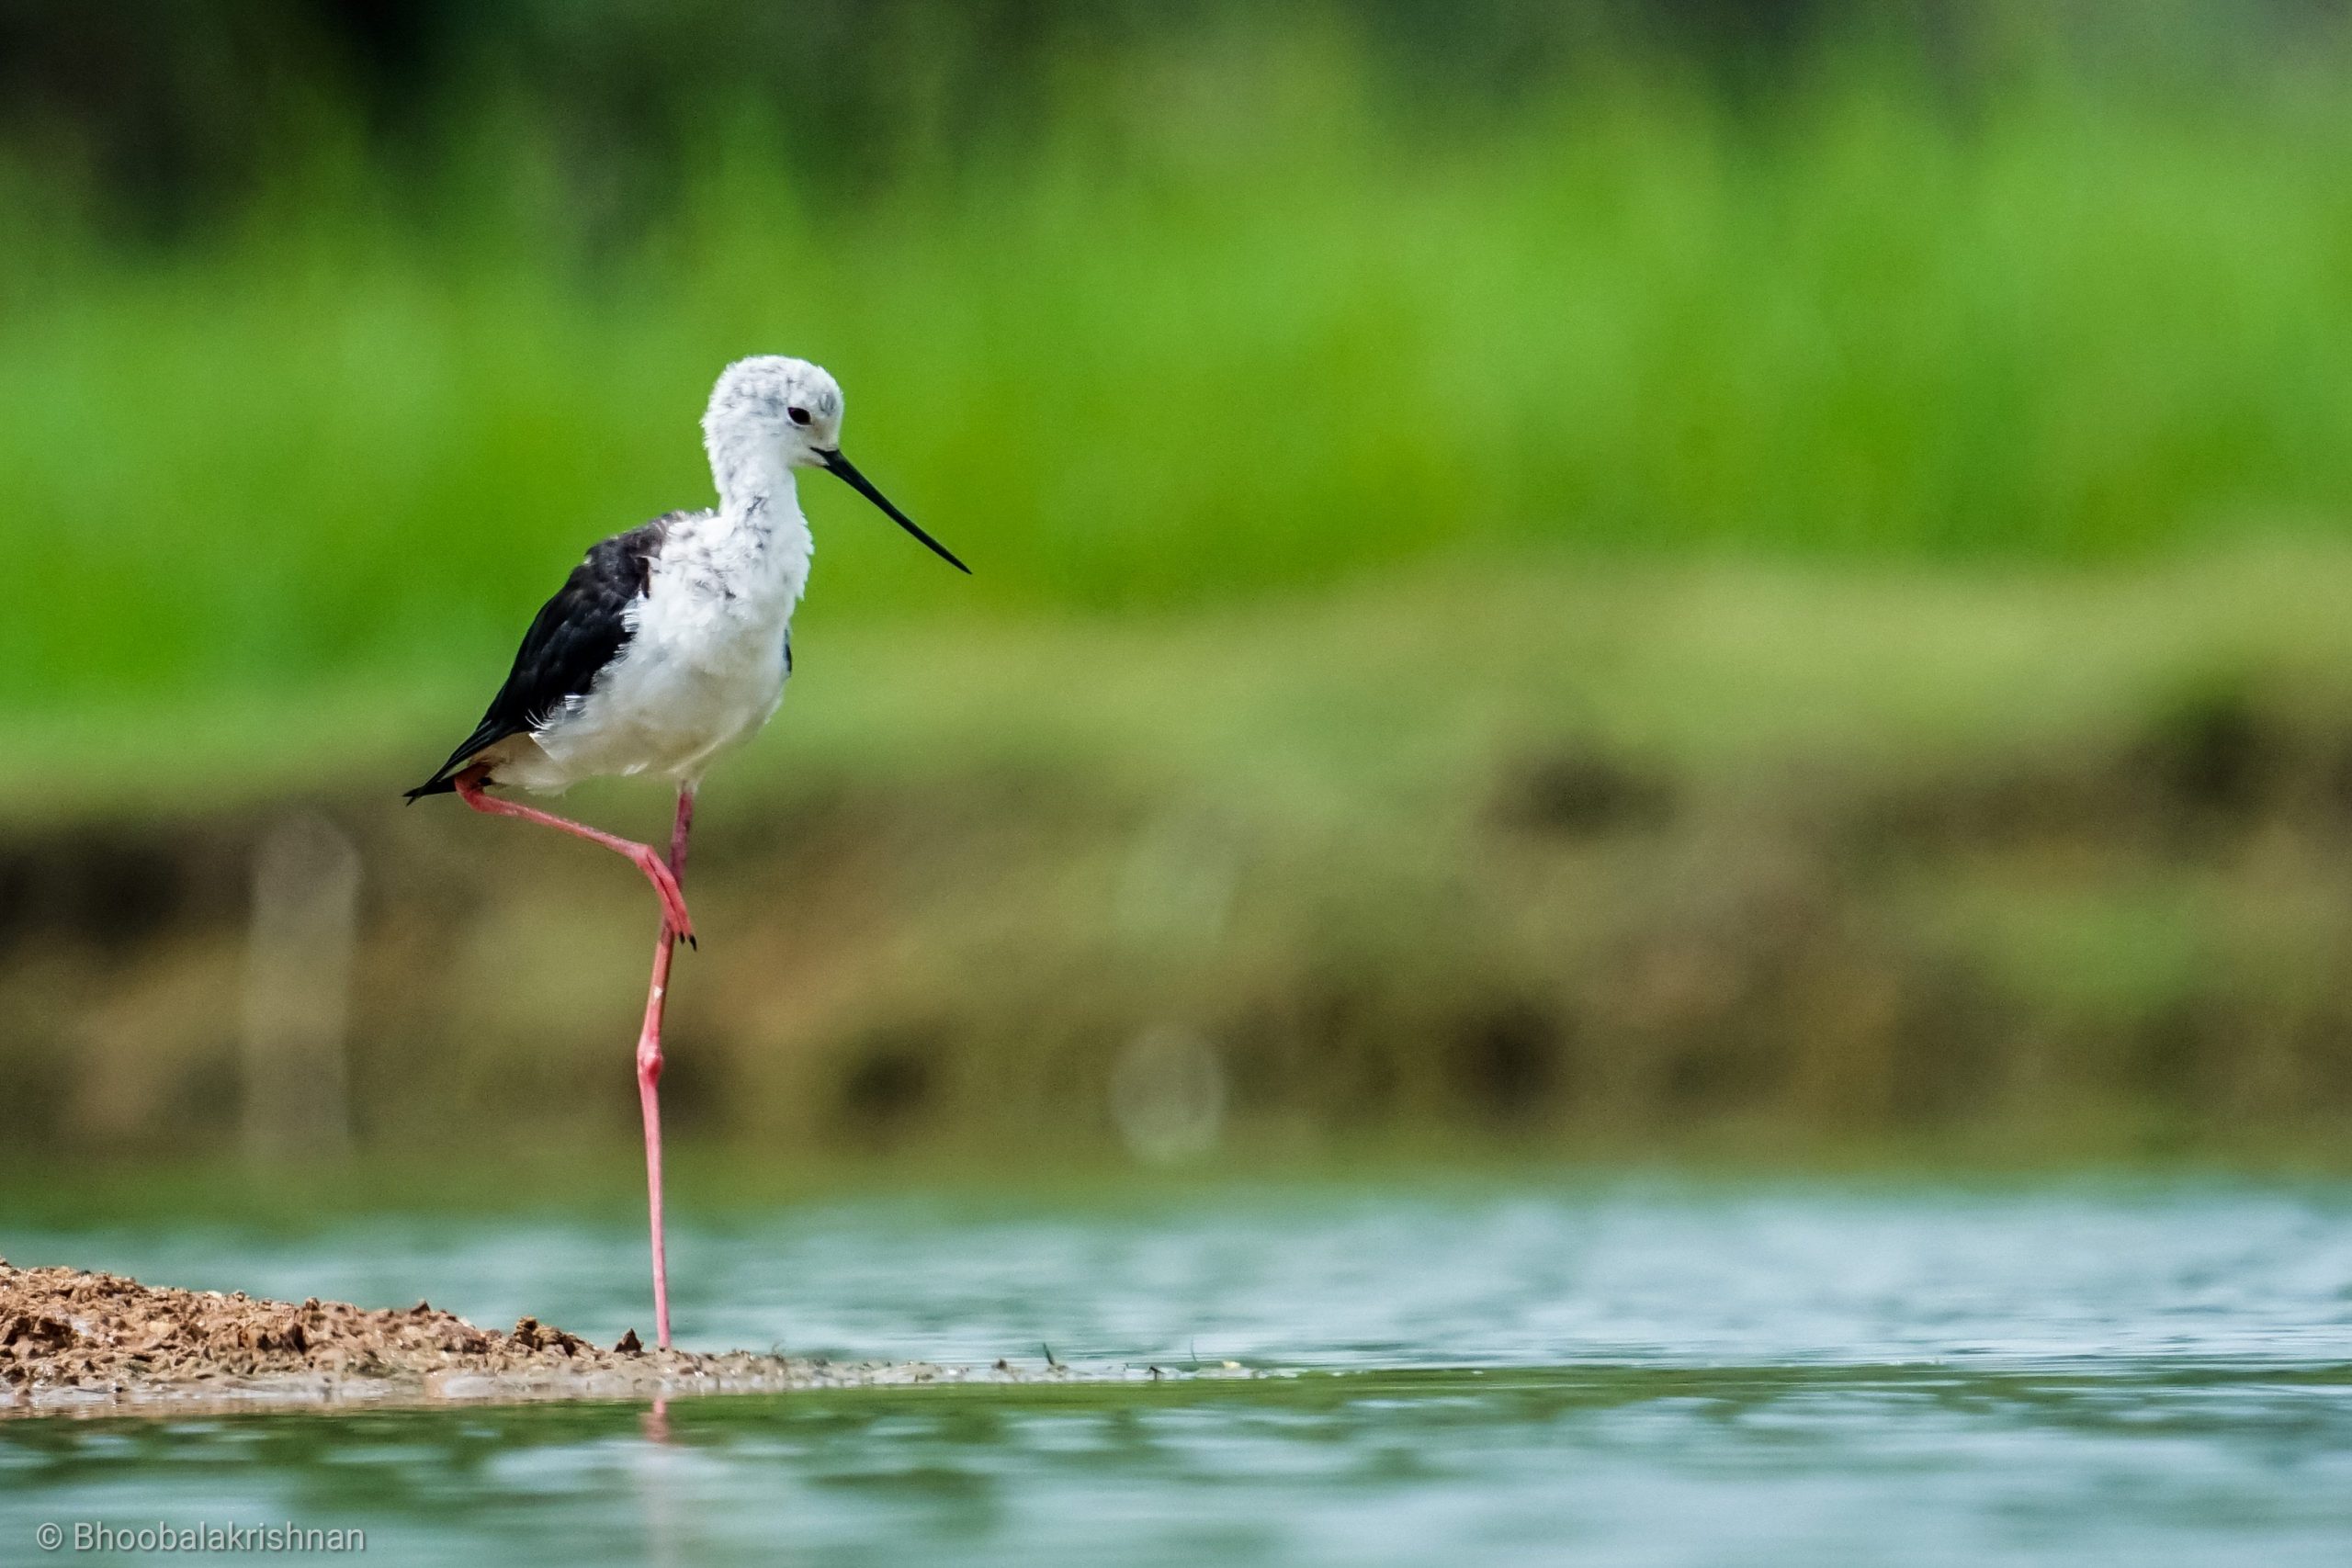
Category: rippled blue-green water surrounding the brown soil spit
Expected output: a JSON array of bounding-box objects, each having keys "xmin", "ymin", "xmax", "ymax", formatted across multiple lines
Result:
[{"xmin": 0, "ymin": 1185, "xmax": 2352, "ymax": 1568}]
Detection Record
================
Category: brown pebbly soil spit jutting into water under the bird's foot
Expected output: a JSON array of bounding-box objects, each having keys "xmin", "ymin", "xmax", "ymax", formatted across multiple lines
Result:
[{"xmin": 0, "ymin": 1260, "xmax": 1176, "ymax": 1416}]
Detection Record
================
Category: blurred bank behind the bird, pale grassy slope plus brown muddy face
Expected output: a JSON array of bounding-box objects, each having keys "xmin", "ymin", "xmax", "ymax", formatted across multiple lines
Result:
[{"xmin": 0, "ymin": 559, "xmax": 2352, "ymax": 1164}]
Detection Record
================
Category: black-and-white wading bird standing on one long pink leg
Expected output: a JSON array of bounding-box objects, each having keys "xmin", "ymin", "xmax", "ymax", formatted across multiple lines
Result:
[{"xmin": 407, "ymin": 355, "xmax": 971, "ymax": 1349}]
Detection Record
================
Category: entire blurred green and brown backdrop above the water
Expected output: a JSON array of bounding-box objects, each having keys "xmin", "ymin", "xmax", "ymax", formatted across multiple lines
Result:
[{"xmin": 0, "ymin": 0, "xmax": 2352, "ymax": 1190}]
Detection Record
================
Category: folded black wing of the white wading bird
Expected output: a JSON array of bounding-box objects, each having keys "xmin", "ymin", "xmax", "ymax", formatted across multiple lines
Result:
[{"xmin": 409, "ymin": 513, "xmax": 687, "ymax": 799}]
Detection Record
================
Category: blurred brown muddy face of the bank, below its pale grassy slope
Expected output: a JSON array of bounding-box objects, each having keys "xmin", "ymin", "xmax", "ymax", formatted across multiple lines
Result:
[{"xmin": 14, "ymin": 698, "xmax": 2352, "ymax": 1159}]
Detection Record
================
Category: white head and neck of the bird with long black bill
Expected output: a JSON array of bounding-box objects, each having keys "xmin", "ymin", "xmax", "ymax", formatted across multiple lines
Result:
[{"xmin": 703, "ymin": 355, "xmax": 969, "ymax": 571}]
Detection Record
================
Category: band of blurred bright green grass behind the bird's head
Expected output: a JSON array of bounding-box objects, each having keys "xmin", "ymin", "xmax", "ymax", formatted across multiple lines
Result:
[{"xmin": 14, "ymin": 30, "xmax": 2352, "ymax": 722}]
